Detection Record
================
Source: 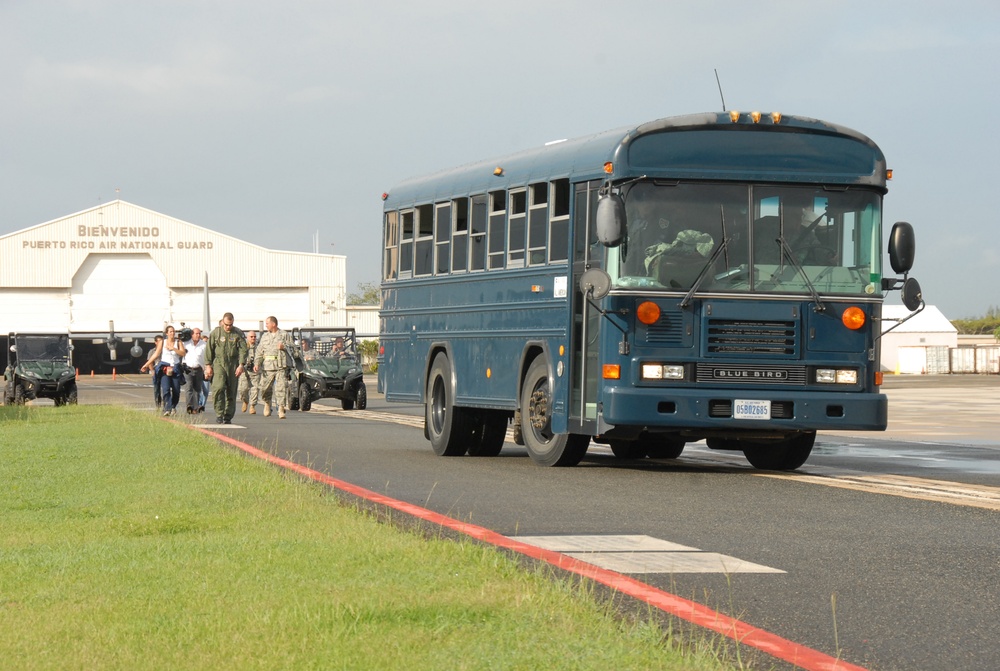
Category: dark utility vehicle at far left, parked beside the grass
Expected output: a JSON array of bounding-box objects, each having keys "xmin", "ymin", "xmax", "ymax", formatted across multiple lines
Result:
[{"xmin": 3, "ymin": 333, "xmax": 77, "ymax": 405}]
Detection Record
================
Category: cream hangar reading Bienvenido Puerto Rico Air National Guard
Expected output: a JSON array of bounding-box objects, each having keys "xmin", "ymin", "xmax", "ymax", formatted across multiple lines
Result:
[{"xmin": 0, "ymin": 200, "xmax": 360, "ymax": 374}]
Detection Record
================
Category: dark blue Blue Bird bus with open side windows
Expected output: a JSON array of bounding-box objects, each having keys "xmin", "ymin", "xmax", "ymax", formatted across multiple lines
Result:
[{"xmin": 378, "ymin": 112, "xmax": 923, "ymax": 470}]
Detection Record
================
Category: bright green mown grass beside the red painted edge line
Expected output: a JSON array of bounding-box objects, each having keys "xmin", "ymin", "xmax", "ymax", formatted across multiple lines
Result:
[{"xmin": 0, "ymin": 406, "xmax": 731, "ymax": 671}]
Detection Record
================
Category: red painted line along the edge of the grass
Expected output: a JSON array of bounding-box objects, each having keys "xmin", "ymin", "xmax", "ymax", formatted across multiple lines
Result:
[{"xmin": 197, "ymin": 425, "xmax": 866, "ymax": 671}]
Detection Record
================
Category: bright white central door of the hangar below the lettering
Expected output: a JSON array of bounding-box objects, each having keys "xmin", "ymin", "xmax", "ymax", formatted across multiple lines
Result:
[{"xmin": 70, "ymin": 254, "xmax": 170, "ymax": 333}]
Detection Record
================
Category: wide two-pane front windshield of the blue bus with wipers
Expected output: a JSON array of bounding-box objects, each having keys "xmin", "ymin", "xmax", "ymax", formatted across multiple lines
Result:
[{"xmin": 607, "ymin": 181, "xmax": 882, "ymax": 295}]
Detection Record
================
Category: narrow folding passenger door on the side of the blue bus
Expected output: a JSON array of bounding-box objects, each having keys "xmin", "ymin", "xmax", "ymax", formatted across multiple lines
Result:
[{"xmin": 568, "ymin": 180, "xmax": 604, "ymax": 435}]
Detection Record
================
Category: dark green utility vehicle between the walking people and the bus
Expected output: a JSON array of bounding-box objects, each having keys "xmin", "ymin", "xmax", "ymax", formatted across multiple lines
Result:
[{"xmin": 288, "ymin": 328, "xmax": 368, "ymax": 410}]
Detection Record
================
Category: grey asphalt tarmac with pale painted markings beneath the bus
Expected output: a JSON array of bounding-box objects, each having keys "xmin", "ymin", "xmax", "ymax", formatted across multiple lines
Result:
[{"xmin": 68, "ymin": 376, "xmax": 1000, "ymax": 671}]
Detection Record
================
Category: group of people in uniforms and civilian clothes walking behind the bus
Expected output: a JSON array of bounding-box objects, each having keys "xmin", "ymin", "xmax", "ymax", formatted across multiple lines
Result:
[{"xmin": 141, "ymin": 312, "xmax": 293, "ymax": 424}]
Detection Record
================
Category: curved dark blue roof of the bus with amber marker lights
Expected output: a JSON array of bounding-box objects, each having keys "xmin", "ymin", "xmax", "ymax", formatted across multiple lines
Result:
[{"xmin": 385, "ymin": 112, "xmax": 885, "ymax": 210}]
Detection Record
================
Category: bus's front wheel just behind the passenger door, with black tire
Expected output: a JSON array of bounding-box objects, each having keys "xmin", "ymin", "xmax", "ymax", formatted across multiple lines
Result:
[{"xmin": 520, "ymin": 356, "xmax": 590, "ymax": 466}]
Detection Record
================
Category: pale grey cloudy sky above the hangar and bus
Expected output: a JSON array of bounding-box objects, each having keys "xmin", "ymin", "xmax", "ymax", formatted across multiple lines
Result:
[{"xmin": 0, "ymin": 0, "xmax": 1000, "ymax": 318}]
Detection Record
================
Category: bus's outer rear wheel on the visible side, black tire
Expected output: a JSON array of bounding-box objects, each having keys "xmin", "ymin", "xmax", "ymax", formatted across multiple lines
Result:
[{"xmin": 424, "ymin": 352, "xmax": 477, "ymax": 457}]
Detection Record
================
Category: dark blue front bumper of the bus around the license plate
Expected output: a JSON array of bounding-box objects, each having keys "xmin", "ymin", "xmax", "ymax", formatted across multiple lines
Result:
[{"xmin": 602, "ymin": 387, "xmax": 888, "ymax": 433}]
